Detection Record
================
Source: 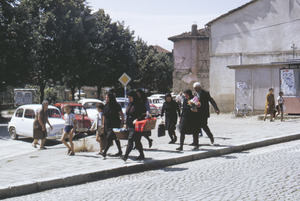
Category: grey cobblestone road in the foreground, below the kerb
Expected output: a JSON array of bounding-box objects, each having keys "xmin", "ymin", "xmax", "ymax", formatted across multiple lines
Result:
[{"xmin": 8, "ymin": 140, "xmax": 300, "ymax": 201}]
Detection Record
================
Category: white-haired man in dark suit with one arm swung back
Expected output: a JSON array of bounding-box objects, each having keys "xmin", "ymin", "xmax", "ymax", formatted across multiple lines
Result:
[{"xmin": 193, "ymin": 82, "xmax": 220, "ymax": 144}]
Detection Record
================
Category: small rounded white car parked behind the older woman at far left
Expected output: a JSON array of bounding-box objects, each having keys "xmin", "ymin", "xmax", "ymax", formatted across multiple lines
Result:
[{"xmin": 7, "ymin": 104, "xmax": 65, "ymax": 140}]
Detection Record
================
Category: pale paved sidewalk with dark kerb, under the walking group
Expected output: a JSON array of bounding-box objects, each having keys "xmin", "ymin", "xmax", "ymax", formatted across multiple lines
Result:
[{"xmin": 0, "ymin": 114, "xmax": 300, "ymax": 199}]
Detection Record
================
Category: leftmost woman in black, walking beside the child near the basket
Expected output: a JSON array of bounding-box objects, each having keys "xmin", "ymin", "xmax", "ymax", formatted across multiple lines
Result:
[{"xmin": 101, "ymin": 93, "xmax": 124, "ymax": 158}]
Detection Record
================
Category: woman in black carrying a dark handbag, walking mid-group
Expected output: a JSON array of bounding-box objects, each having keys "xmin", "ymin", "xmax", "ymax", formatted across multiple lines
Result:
[{"xmin": 161, "ymin": 93, "xmax": 180, "ymax": 144}]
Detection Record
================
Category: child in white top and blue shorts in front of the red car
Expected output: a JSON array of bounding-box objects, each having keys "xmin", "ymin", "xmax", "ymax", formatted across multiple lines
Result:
[{"xmin": 61, "ymin": 104, "xmax": 76, "ymax": 156}]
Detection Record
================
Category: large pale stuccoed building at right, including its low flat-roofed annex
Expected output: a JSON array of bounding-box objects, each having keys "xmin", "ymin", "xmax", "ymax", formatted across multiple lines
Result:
[{"xmin": 206, "ymin": 0, "xmax": 300, "ymax": 113}]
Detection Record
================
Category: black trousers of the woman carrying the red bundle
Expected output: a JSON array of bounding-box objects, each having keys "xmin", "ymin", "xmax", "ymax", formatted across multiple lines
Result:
[{"xmin": 124, "ymin": 128, "xmax": 144, "ymax": 158}]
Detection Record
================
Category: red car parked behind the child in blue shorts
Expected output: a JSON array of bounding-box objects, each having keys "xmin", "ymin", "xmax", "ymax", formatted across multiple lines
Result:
[{"xmin": 54, "ymin": 103, "xmax": 92, "ymax": 134}]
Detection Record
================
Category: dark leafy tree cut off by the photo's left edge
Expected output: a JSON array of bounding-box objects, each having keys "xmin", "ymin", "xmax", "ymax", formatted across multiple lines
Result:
[{"xmin": 0, "ymin": 0, "xmax": 30, "ymax": 91}]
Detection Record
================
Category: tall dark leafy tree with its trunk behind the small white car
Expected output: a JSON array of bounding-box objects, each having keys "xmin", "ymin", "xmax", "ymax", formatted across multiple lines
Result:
[{"xmin": 20, "ymin": 0, "xmax": 90, "ymax": 102}]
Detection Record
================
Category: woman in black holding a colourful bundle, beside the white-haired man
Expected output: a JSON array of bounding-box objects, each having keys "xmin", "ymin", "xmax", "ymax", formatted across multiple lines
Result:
[{"xmin": 176, "ymin": 89, "xmax": 200, "ymax": 151}]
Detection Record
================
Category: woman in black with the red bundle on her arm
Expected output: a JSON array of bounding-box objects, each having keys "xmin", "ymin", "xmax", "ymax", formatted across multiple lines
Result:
[{"xmin": 122, "ymin": 91, "xmax": 145, "ymax": 161}]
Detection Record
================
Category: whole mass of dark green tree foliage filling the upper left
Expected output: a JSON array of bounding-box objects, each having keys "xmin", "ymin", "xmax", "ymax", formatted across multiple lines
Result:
[{"xmin": 0, "ymin": 0, "xmax": 172, "ymax": 101}]
